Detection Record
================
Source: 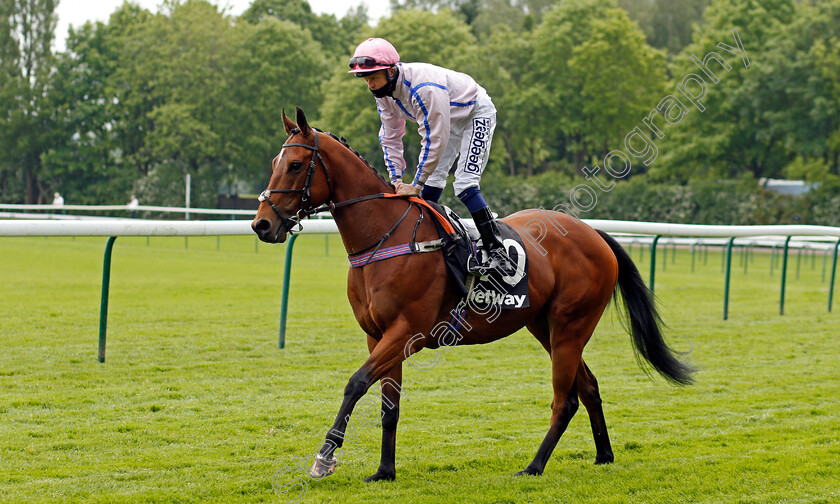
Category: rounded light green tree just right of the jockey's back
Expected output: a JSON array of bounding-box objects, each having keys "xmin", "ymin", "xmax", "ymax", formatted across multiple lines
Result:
[{"xmin": 526, "ymin": 0, "xmax": 666, "ymax": 169}]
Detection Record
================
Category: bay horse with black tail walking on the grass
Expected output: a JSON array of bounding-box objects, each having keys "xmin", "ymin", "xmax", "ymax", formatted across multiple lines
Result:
[{"xmin": 251, "ymin": 108, "xmax": 694, "ymax": 481}]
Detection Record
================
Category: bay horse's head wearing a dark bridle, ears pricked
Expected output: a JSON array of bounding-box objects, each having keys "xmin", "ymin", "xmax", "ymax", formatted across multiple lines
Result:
[{"xmin": 251, "ymin": 108, "xmax": 330, "ymax": 243}]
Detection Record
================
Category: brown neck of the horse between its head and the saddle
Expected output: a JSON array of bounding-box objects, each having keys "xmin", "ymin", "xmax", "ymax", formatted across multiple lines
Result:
[{"xmin": 330, "ymin": 151, "xmax": 405, "ymax": 254}]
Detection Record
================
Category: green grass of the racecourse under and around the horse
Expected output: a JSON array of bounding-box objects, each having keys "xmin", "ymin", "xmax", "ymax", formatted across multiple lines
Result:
[{"xmin": 0, "ymin": 236, "xmax": 840, "ymax": 504}]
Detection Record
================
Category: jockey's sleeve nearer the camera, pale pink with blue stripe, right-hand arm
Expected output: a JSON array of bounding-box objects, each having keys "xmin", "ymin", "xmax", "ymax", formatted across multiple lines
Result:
[{"xmin": 411, "ymin": 82, "xmax": 450, "ymax": 186}]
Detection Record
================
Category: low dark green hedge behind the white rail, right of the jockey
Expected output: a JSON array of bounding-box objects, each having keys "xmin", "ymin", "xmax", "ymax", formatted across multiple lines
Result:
[{"xmin": 476, "ymin": 173, "xmax": 840, "ymax": 226}]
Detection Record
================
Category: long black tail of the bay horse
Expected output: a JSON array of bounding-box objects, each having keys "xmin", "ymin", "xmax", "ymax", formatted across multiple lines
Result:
[{"xmin": 598, "ymin": 230, "xmax": 694, "ymax": 385}]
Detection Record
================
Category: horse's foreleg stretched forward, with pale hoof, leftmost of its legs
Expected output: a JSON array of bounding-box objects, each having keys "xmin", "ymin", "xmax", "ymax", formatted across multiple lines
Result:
[{"xmin": 309, "ymin": 331, "xmax": 408, "ymax": 479}]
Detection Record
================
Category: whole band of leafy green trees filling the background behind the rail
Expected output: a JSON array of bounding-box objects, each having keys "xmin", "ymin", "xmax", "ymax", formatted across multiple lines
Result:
[{"xmin": 0, "ymin": 0, "xmax": 840, "ymax": 223}]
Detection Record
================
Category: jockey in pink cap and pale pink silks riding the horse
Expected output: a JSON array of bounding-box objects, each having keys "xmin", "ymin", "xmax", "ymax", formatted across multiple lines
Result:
[{"xmin": 348, "ymin": 38, "xmax": 516, "ymax": 275}]
